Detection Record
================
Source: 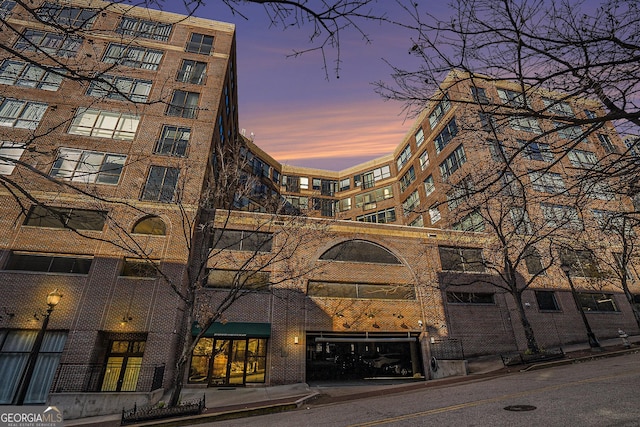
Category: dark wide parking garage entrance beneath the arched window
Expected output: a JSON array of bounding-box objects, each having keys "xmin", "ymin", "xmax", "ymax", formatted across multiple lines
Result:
[{"xmin": 306, "ymin": 332, "xmax": 424, "ymax": 381}]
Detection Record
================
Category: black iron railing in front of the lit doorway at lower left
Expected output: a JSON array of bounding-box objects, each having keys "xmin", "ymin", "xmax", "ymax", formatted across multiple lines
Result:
[{"xmin": 51, "ymin": 363, "xmax": 164, "ymax": 393}]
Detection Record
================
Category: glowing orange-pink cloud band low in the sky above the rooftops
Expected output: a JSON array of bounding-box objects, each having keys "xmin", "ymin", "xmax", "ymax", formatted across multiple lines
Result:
[{"xmin": 240, "ymin": 100, "xmax": 412, "ymax": 170}]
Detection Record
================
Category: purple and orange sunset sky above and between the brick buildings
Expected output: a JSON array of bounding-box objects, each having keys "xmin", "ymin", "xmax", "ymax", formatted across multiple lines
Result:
[{"xmin": 166, "ymin": 0, "xmax": 448, "ymax": 170}]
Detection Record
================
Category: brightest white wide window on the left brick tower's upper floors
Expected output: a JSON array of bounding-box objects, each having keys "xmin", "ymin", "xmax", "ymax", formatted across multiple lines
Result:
[{"xmin": 69, "ymin": 108, "xmax": 140, "ymax": 141}]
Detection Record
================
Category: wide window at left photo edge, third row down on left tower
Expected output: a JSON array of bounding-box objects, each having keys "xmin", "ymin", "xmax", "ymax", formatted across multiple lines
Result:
[{"xmin": 0, "ymin": 59, "xmax": 63, "ymax": 92}]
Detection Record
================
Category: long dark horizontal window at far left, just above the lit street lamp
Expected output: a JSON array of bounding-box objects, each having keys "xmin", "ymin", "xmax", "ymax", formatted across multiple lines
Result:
[{"xmin": 5, "ymin": 252, "xmax": 93, "ymax": 274}]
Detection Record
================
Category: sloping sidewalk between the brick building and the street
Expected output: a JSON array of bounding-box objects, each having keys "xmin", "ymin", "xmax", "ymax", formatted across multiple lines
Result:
[{"xmin": 64, "ymin": 335, "xmax": 640, "ymax": 427}]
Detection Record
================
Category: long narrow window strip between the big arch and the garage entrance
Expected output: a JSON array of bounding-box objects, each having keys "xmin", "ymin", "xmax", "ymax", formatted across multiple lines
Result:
[{"xmin": 307, "ymin": 280, "xmax": 416, "ymax": 300}]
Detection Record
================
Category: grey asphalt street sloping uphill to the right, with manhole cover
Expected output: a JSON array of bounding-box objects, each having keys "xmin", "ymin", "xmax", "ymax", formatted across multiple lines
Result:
[{"xmin": 203, "ymin": 354, "xmax": 640, "ymax": 427}]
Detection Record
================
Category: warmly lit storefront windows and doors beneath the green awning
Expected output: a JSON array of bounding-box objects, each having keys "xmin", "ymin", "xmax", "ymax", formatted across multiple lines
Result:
[{"xmin": 188, "ymin": 337, "xmax": 267, "ymax": 386}]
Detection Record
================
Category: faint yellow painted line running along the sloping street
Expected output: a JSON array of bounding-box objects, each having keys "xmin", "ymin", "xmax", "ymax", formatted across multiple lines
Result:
[{"xmin": 347, "ymin": 369, "xmax": 640, "ymax": 427}]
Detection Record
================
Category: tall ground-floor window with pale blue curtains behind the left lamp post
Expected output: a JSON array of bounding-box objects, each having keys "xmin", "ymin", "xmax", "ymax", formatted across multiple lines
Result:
[{"xmin": 0, "ymin": 330, "xmax": 67, "ymax": 405}]
